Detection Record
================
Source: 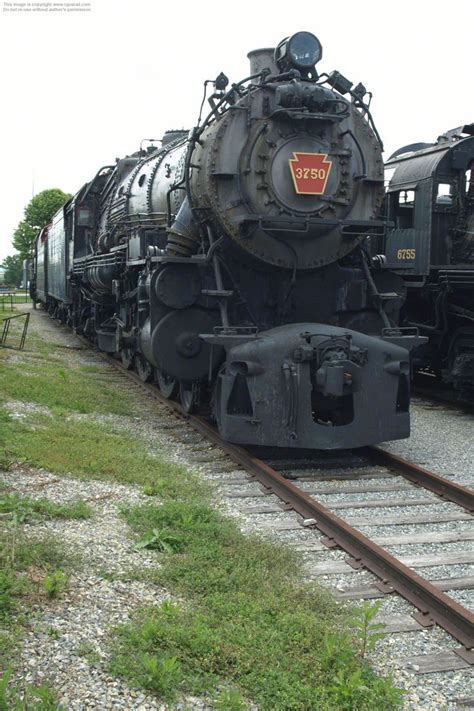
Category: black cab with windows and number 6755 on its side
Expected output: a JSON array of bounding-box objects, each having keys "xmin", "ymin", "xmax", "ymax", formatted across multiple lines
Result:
[{"xmin": 386, "ymin": 124, "xmax": 474, "ymax": 280}]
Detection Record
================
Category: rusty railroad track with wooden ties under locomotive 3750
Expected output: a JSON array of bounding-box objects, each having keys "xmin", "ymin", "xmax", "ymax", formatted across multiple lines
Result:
[{"xmin": 52, "ymin": 320, "xmax": 474, "ymax": 673}]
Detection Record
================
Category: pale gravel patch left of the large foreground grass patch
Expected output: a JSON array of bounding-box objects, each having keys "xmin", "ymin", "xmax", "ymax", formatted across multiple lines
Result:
[{"xmin": 1, "ymin": 469, "xmax": 218, "ymax": 711}]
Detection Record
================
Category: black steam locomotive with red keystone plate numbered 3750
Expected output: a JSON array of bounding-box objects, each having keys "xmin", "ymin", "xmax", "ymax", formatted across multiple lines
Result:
[{"xmin": 33, "ymin": 32, "xmax": 419, "ymax": 449}]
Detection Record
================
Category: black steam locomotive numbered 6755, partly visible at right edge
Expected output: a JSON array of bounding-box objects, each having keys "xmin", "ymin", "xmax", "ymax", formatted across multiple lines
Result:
[{"xmin": 385, "ymin": 124, "xmax": 474, "ymax": 404}]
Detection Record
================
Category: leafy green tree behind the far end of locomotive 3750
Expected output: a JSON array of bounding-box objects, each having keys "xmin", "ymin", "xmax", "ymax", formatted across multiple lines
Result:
[{"xmin": 12, "ymin": 188, "xmax": 71, "ymax": 259}]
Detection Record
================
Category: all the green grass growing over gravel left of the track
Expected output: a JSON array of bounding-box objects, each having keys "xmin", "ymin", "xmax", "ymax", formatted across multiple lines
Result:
[{"xmin": 0, "ymin": 312, "xmax": 400, "ymax": 711}]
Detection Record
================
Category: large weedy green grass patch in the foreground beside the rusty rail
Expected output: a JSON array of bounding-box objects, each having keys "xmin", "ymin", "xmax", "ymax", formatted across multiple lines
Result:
[{"xmin": 112, "ymin": 501, "xmax": 400, "ymax": 711}]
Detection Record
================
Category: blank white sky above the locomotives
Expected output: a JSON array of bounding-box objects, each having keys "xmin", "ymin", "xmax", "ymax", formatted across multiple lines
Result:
[{"xmin": 0, "ymin": 0, "xmax": 474, "ymax": 260}]
